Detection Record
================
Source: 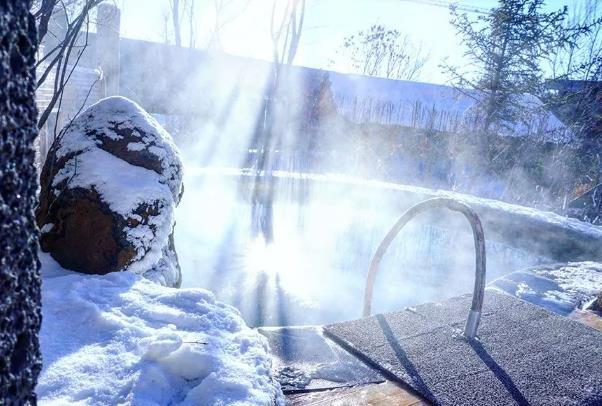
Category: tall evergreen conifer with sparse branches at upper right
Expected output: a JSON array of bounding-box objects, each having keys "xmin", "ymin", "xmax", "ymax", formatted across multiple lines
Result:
[{"xmin": 444, "ymin": 0, "xmax": 567, "ymax": 137}]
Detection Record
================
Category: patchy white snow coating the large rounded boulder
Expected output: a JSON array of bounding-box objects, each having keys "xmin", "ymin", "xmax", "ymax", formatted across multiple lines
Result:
[{"xmin": 41, "ymin": 97, "xmax": 182, "ymax": 285}]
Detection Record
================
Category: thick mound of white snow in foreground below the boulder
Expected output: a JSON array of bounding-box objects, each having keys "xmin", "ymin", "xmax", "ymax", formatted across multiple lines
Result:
[{"xmin": 36, "ymin": 253, "xmax": 282, "ymax": 405}]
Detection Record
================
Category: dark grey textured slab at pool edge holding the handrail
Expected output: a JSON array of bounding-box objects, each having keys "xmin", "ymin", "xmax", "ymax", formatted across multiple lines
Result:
[{"xmin": 324, "ymin": 291, "xmax": 602, "ymax": 405}]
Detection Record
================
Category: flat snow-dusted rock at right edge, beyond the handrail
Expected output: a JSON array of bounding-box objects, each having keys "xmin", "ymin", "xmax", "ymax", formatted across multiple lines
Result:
[{"xmin": 488, "ymin": 262, "xmax": 602, "ymax": 315}]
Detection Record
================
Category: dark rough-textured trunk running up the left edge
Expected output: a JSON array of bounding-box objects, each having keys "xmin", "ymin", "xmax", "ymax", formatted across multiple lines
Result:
[{"xmin": 0, "ymin": 0, "xmax": 42, "ymax": 405}]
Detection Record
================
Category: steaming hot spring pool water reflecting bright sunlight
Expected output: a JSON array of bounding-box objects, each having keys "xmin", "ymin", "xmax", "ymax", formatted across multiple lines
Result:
[{"xmin": 175, "ymin": 169, "xmax": 602, "ymax": 326}]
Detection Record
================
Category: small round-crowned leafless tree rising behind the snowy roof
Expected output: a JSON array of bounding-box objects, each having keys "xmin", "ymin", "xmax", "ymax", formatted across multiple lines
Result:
[{"xmin": 342, "ymin": 25, "xmax": 428, "ymax": 80}]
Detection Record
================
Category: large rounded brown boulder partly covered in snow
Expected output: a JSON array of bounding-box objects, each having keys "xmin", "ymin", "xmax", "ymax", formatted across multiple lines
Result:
[{"xmin": 37, "ymin": 97, "xmax": 183, "ymax": 287}]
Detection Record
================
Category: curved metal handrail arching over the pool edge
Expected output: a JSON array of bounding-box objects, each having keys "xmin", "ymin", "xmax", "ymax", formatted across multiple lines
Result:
[{"xmin": 364, "ymin": 197, "xmax": 487, "ymax": 339}]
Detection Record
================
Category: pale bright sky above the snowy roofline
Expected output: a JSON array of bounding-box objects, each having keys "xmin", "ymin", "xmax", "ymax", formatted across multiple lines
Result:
[{"xmin": 117, "ymin": 0, "xmax": 578, "ymax": 83}]
